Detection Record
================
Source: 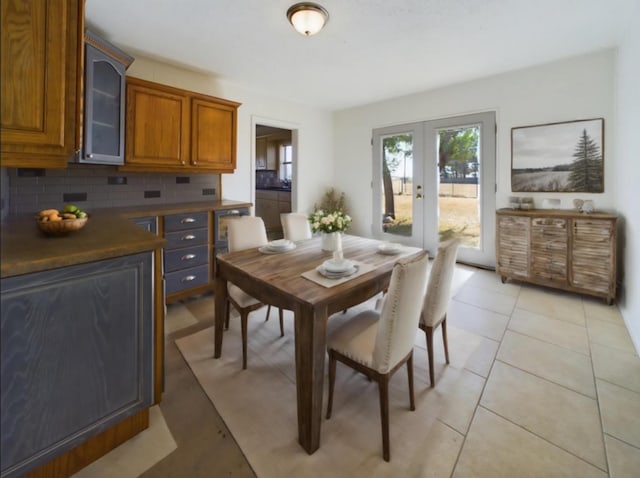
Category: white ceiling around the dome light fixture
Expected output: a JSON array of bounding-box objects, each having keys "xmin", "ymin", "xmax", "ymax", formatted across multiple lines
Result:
[{"xmin": 86, "ymin": 0, "xmax": 640, "ymax": 110}]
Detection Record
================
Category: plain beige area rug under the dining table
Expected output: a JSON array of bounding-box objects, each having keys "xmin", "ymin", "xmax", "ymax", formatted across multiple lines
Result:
[{"xmin": 176, "ymin": 296, "xmax": 480, "ymax": 478}]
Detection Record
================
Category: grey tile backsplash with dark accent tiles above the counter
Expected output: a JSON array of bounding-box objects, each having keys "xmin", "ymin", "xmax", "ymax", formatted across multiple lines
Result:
[{"xmin": 2, "ymin": 164, "xmax": 220, "ymax": 218}]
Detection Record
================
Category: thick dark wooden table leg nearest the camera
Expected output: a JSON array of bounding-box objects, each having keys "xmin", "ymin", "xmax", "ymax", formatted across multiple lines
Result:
[{"xmin": 294, "ymin": 305, "xmax": 327, "ymax": 455}]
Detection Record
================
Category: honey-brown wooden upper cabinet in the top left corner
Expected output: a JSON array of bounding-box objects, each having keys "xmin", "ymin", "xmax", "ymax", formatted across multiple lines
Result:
[{"xmin": 0, "ymin": 0, "xmax": 84, "ymax": 168}]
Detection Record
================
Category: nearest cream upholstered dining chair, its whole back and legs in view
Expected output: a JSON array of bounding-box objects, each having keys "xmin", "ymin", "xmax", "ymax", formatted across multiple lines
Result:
[{"xmin": 327, "ymin": 252, "xmax": 429, "ymax": 461}]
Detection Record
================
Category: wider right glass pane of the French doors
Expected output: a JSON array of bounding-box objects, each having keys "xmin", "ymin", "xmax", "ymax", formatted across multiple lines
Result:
[{"xmin": 436, "ymin": 126, "xmax": 480, "ymax": 248}]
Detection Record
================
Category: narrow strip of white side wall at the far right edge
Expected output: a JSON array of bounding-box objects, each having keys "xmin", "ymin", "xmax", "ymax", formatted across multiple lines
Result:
[{"xmin": 615, "ymin": 5, "xmax": 640, "ymax": 352}]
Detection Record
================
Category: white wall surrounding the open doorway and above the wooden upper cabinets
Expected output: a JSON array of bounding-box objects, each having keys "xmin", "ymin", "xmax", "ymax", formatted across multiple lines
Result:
[{"xmin": 127, "ymin": 56, "xmax": 333, "ymax": 217}]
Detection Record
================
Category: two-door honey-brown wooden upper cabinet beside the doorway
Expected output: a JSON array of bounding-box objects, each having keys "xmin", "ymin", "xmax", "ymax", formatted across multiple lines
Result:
[{"xmin": 120, "ymin": 77, "xmax": 239, "ymax": 173}]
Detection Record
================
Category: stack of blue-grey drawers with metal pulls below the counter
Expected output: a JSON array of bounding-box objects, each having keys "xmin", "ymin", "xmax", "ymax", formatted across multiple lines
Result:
[{"xmin": 164, "ymin": 211, "xmax": 213, "ymax": 303}]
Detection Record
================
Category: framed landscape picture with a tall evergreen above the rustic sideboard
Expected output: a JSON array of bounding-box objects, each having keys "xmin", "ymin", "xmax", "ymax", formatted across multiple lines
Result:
[{"xmin": 511, "ymin": 118, "xmax": 604, "ymax": 193}]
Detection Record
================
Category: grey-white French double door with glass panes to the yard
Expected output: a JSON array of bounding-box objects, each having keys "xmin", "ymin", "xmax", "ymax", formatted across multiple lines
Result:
[{"xmin": 373, "ymin": 112, "xmax": 496, "ymax": 267}]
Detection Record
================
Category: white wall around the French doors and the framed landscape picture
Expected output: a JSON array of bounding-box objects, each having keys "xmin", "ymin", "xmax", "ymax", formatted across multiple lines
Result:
[{"xmin": 334, "ymin": 50, "xmax": 616, "ymax": 234}]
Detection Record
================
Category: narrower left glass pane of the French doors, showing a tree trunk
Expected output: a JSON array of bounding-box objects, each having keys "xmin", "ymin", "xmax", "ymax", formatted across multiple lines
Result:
[{"xmin": 382, "ymin": 133, "xmax": 413, "ymax": 237}]
